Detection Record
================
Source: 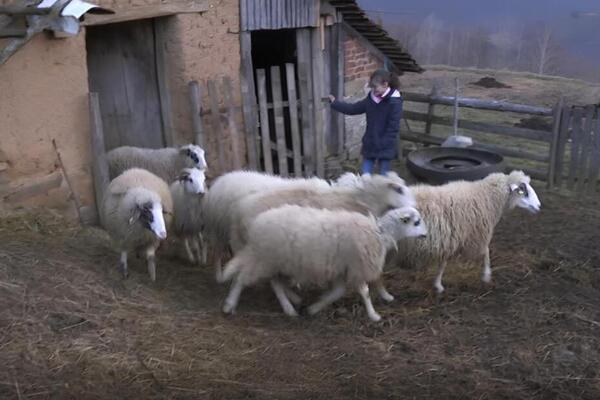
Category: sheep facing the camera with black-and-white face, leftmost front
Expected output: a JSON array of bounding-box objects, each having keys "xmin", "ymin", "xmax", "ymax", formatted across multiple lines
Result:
[{"xmin": 102, "ymin": 168, "xmax": 173, "ymax": 282}]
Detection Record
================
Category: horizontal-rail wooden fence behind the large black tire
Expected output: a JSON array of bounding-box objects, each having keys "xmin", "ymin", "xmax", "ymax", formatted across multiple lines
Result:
[{"xmin": 401, "ymin": 90, "xmax": 563, "ymax": 182}]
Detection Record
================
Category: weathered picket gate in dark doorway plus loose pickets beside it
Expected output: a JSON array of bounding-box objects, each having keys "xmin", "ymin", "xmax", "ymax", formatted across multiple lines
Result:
[{"xmin": 189, "ymin": 63, "xmax": 325, "ymax": 177}]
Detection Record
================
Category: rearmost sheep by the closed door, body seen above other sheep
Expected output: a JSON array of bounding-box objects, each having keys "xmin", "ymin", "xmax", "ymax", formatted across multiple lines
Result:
[{"xmin": 106, "ymin": 144, "xmax": 207, "ymax": 182}]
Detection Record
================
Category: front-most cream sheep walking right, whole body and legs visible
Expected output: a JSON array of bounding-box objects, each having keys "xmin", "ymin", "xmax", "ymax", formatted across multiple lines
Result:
[{"xmin": 221, "ymin": 205, "xmax": 427, "ymax": 321}]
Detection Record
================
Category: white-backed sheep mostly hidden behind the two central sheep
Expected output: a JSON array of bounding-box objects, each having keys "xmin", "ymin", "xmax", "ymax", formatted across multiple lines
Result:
[{"xmin": 202, "ymin": 171, "xmax": 329, "ymax": 278}]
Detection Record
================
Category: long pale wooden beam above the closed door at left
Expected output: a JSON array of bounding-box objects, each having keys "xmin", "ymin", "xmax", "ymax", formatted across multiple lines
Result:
[{"xmin": 81, "ymin": 0, "xmax": 209, "ymax": 26}]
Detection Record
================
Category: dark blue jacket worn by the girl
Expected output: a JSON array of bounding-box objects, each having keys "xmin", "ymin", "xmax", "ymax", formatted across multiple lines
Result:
[{"xmin": 331, "ymin": 90, "xmax": 402, "ymax": 160}]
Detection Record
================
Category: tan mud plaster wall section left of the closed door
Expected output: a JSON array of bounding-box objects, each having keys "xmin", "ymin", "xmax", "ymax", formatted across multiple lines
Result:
[{"xmin": 0, "ymin": 34, "xmax": 93, "ymax": 216}]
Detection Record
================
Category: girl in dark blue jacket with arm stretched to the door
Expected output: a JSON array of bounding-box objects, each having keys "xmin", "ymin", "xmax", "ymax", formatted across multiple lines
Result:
[{"xmin": 329, "ymin": 69, "xmax": 402, "ymax": 175}]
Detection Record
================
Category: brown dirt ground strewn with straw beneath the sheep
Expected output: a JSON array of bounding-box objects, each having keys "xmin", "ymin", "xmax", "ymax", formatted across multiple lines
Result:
[{"xmin": 0, "ymin": 186, "xmax": 600, "ymax": 399}]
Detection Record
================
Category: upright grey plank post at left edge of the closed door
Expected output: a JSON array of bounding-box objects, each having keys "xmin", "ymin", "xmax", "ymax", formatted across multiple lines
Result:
[{"xmin": 89, "ymin": 92, "xmax": 110, "ymax": 227}]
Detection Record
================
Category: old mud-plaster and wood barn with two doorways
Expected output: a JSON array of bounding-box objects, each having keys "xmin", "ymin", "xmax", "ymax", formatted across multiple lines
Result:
[{"xmin": 0, "ymin": 0, "xmax": 421, "ymax": 222}]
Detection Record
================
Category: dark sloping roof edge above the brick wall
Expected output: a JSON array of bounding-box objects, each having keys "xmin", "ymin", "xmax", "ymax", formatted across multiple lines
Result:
[{"xmin": 329, "ymin": 0, "xmax": 424, "ymax": 72}]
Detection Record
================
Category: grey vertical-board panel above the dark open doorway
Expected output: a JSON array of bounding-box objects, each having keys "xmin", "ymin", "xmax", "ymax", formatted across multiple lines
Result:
[{"xmin": 240, "ymin": 0, "xmax": 319, "ymax": 31}]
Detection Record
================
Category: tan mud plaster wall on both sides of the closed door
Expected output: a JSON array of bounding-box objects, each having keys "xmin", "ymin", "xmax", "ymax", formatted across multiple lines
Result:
[{"xmin": 0, "ymin": 0, "xmax": 245, "ymax": 217}]
